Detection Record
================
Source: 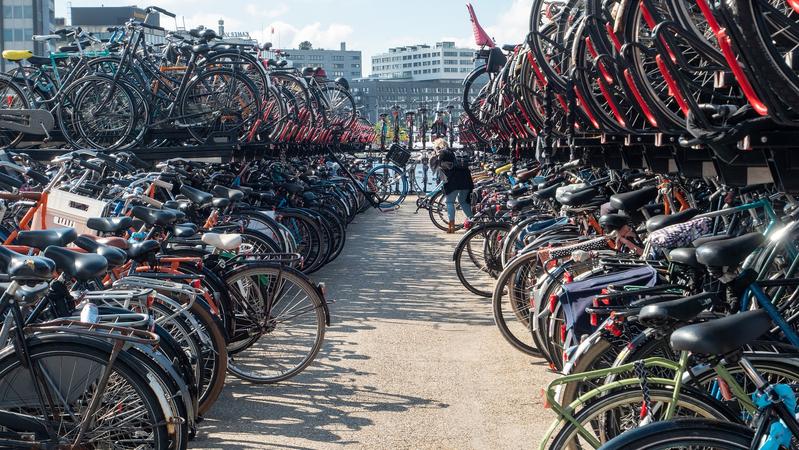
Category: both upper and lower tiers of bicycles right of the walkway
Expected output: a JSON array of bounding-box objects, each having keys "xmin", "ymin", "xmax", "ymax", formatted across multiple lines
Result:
[{"xmin": 453, "ymin": 0, "xmax": 799, "ymax": 450}]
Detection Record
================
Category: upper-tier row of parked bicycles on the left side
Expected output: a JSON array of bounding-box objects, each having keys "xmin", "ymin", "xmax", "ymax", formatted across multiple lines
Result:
[{"xmin": 0, "ymin": 6, "xmax": 375, "ymax": 150}]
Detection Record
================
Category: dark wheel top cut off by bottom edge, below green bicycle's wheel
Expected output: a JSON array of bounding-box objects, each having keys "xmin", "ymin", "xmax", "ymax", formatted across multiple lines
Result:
[{"xmin": 600, "ymin": 419, "xmax": 754, "ymax": 450}]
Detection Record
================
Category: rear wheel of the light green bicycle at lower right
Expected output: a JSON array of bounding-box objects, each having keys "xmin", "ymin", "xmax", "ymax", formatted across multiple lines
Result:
[{"xmin": 549, "ymin": 386, "xmax": 734, "ymax": 450}]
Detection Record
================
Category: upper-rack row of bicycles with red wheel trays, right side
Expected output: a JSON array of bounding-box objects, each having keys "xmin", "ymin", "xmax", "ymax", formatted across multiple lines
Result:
[{"xmin": 461, "ymin": 0, "xmax": 799, "ymax": 169}]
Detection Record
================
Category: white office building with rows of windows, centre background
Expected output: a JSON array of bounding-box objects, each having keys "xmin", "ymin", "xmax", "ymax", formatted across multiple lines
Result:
[{"xmin": 370, "ymin": 42, "xmax": 475, "ymax": 81}]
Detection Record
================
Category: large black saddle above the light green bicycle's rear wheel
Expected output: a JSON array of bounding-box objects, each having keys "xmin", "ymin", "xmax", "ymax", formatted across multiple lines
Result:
[{"xmin": 670, "ymin": 309, "xmax": 771, "ymax": 355}]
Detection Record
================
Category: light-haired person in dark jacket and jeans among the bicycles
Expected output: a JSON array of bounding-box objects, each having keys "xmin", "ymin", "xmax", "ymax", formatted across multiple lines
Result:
[{"xmin": 433, "ymin": 139, "xmax": 474, "ymax": 234}]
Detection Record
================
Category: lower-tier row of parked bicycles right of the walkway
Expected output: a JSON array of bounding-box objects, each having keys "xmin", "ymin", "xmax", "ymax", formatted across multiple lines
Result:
[{"xmin": 446, "ymin": 154, "xmax": 799, "ymax": 450}]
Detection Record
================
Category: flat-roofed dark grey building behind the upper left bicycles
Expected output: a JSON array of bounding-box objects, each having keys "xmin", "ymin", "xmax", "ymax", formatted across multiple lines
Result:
[{"xmin": 71, "ymin": 6, "xmax": 166, "ymax": 44}]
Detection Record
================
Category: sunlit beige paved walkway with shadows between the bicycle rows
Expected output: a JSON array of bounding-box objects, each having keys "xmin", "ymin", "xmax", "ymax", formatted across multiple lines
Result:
[{"xmin": 193, "ymin": 204, "xmax": 553, "ymax": 449}]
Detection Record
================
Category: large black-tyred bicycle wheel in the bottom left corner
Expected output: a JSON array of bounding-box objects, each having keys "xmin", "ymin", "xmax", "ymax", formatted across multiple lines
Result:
[{"xmin": 0, "ymin": 335, "xmax": 169, "ymax": 449}]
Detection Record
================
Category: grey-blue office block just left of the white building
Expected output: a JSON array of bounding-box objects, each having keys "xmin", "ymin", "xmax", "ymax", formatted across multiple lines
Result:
[{"xmin": 286, "ymin": 42, "xmax": 363, "ymax": 80}]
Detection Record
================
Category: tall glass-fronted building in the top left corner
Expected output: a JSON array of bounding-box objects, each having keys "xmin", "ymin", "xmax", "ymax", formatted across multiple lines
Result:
[{"xmin": 0, "ymin": 0, "xmax": 55, "ymax": 71}]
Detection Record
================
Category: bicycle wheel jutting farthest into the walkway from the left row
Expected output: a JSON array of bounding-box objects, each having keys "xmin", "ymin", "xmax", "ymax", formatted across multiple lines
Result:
[{"xmin": 225, "ymin": 263, "xmax": 326, "ymax": 383}]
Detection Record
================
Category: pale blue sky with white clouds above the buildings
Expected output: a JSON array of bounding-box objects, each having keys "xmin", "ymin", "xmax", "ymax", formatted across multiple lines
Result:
[{"xmin": 55, "ymin": 0, "xmax": 532, "ymax": 74}]
